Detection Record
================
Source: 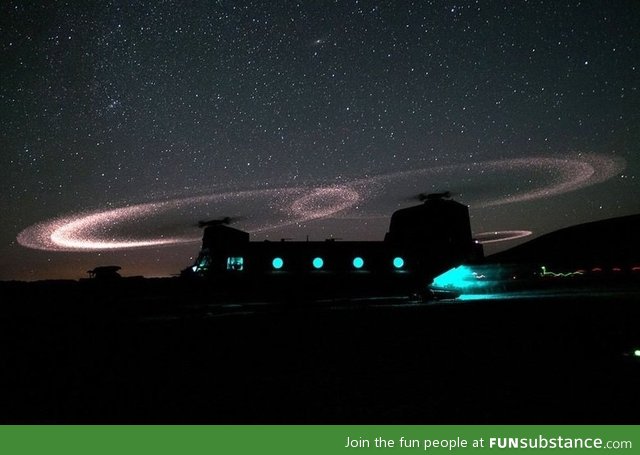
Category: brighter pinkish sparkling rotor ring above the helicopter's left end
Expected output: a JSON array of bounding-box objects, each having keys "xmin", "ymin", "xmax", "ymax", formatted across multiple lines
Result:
[{"xmin": 17, "ymin": 186, "xmax": 360, "ymax": 251}]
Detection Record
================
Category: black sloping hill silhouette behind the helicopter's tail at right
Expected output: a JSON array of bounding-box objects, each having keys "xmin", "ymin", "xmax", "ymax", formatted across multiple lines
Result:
[{"xmin": 486, "ymin": 214, "xmax": 640, "ymax": 267}]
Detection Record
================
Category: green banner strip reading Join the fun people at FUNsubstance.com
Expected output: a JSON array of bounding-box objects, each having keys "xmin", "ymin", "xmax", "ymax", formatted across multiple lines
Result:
[{"xmin": 0, "ymin": 425, "xmax": 640, "ymax": 455}]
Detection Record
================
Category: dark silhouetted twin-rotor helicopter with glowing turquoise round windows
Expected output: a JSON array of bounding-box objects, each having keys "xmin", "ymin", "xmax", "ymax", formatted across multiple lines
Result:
[{"xmin": 182, "ymin": 192, "xmax": 483, "ymax": 298}]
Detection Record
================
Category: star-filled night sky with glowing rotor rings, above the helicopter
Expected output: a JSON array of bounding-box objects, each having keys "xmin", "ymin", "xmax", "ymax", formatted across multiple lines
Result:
[{"xmin": 0, "ymin": 0, "xmax": 640, "ymax": 280}]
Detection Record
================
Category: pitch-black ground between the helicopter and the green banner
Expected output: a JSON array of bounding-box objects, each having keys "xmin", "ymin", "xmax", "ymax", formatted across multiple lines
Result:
[{"xmin": 0, "ymin": 281, "xmax": 640, "ymax": 424}]
